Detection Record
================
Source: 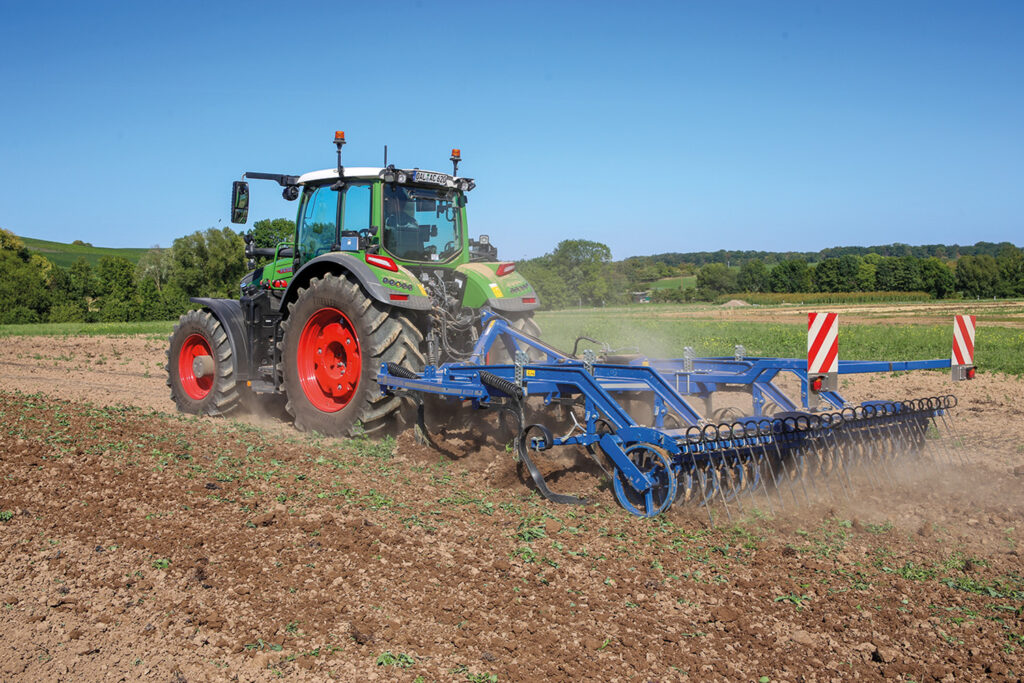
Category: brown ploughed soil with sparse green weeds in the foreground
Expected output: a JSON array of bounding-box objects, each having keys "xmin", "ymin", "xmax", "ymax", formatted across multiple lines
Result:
[{"xmin": 0, "ymin": 337, "xmax": 1024, "ymax": 681}]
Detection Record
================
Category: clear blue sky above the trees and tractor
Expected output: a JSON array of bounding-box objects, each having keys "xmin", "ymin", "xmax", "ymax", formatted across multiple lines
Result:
[{"xmin": 0, "ymin": 0, "xmax": 1024, "ymax": 258}]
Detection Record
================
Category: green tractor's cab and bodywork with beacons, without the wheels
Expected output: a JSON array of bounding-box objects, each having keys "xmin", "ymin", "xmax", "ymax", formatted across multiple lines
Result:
[{"xmin": 231, "ymin": 131, "xmax": 540, "ymax": 370}]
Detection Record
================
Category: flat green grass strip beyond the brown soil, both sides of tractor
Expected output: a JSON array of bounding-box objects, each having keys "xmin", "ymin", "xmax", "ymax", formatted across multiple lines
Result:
[{"xmin": 0, "ymin": 304, "xmax": 1024, "ymax": 376}]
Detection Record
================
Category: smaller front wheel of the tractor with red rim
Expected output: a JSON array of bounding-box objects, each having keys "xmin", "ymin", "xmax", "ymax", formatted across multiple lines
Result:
[{"xmin": 167, "ymin": 310, "xmax": 240, "ymax": 415}]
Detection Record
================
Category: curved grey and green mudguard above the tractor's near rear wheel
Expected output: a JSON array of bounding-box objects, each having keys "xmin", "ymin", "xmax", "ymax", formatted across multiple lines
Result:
[{"xmin": 282, "ymin": 252, "xmax": 430, "ymax": 311}]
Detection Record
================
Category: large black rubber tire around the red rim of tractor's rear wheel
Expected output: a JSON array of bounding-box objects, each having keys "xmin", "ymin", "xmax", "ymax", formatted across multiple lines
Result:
[{"xmin": 279, "ymin": 274, "xmax": 426, "ymax": 436}]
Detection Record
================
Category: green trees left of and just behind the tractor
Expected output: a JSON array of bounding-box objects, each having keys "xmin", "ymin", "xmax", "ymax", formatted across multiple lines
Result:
[{"xmin": 0, "ymin": 219, "xmax": 295, "ymax": 325}]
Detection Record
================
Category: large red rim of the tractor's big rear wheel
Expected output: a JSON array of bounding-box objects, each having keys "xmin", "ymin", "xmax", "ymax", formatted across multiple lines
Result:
[{"xmin": 295, "ymin": 308, "xmax": 362, "ymax": 413}]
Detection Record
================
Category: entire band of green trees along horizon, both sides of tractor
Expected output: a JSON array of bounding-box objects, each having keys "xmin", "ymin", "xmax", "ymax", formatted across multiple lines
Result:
[{"xmin": 0, "ymin": 218, "xmax": 1024, "ymax": 325}]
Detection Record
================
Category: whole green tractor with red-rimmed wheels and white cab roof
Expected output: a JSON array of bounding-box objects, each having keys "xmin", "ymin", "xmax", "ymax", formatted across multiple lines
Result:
[{"xmin": 167, "ymin": 131, "xmax": 540, "ymax": 435}]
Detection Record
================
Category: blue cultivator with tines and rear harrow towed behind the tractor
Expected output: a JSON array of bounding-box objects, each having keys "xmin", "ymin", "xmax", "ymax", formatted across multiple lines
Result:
[{"xmin": 377, "ymin": 314, "xmax": 974, "ymax": 517}]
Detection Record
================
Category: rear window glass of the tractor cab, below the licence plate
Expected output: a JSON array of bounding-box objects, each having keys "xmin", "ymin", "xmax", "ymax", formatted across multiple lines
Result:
[{"xmin": 384, "ymin": 184, "xmax": 462, "ymax": 261}]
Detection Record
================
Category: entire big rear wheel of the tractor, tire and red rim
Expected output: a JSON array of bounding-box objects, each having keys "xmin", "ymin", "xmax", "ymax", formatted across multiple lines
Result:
[{"xmin": 279, "ymin": 274, "xmax": 426, "ymax": 436}]
